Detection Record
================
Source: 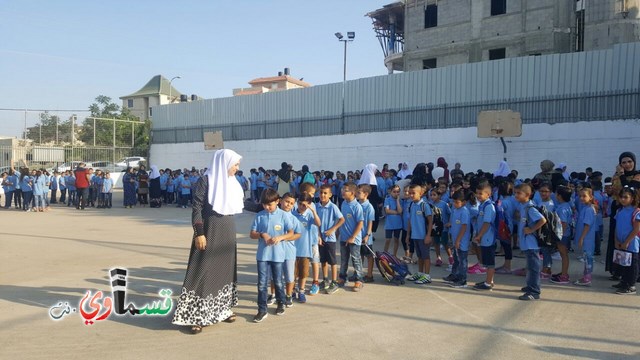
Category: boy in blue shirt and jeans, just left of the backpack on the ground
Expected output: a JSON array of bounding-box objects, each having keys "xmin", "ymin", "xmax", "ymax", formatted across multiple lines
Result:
[{"xmin": 338, "ymin": 182, "xmax": 364, "ymax": 291}]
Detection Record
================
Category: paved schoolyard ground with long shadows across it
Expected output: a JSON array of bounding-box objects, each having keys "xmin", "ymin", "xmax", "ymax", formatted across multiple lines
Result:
[{"xmin": 0, "ymin": 193, "xmax": 640, "ymax": 360}]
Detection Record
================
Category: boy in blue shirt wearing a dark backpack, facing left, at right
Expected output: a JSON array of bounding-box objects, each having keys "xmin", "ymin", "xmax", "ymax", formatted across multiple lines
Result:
[{"xmin": 515, "ymin": 183, "xmax": 547, "ymax": 300}]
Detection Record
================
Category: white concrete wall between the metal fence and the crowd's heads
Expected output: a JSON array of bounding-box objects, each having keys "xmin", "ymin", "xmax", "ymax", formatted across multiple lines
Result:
[{"xmin": 150, "ymin": 120, "xmax": 640, "ymax": 178}]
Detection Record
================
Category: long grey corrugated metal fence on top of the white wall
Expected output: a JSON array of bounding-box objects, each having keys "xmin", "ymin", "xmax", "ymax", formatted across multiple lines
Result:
[{"xmin": 153, "ymin": 43, "xmax": 640, "ymax": 144}]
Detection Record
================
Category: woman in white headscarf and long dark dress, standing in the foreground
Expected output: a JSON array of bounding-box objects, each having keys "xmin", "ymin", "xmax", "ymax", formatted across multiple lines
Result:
[{"xmin": 173, "ymin": 149, "xmax": 244, "ymax": 334}]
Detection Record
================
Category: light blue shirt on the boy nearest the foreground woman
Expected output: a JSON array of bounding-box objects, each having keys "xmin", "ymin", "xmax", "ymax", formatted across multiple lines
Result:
[{"xmin": 251, "ymin": 209, "xmax": 294, "ymax": 262}]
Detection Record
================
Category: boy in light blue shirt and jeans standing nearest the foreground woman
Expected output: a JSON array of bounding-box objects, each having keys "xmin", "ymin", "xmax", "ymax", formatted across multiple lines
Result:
[{"xmin": 249, "ymin": 189, "xmax": 294, "ymax": 323}]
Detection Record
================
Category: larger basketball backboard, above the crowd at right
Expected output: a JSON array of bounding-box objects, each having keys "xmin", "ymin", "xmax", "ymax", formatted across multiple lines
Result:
[{"xmin": 478, "ymin": 110, "xmax": 522, "ymax": 138}]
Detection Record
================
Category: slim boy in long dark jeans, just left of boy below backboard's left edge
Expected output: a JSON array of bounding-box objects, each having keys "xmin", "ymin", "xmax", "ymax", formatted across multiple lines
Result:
[{"xmin": 443, "ymin": 190, "xmax": 471, "ymax": 288}]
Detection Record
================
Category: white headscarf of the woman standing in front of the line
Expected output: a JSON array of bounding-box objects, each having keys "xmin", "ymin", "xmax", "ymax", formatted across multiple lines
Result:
[{"xmin": 205, "ymin": 149, "xmax": 244, "ymax": 215}]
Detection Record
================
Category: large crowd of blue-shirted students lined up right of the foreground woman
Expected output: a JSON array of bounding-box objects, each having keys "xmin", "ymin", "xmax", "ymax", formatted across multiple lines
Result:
[{"xmin": 246, "ymin": 153, "xmax": 640, "ymax": 322}]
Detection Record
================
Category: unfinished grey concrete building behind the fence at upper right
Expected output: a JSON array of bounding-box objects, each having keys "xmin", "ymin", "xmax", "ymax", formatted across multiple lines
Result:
[{"xmin": 366, "ymin": 0, "xmax": 640, "ymax": 73}]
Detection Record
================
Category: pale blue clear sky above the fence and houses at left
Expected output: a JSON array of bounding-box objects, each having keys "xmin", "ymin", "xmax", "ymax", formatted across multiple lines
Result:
[{"xmin": 0, "ymin": 0, "xmax": 393, "ymax": 136}]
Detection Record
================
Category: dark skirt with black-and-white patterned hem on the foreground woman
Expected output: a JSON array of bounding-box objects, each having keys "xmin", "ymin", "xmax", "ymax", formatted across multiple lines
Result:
[{"xmin": 172, "ymin": 215, "xmax": 238, "ymax": 326}]
